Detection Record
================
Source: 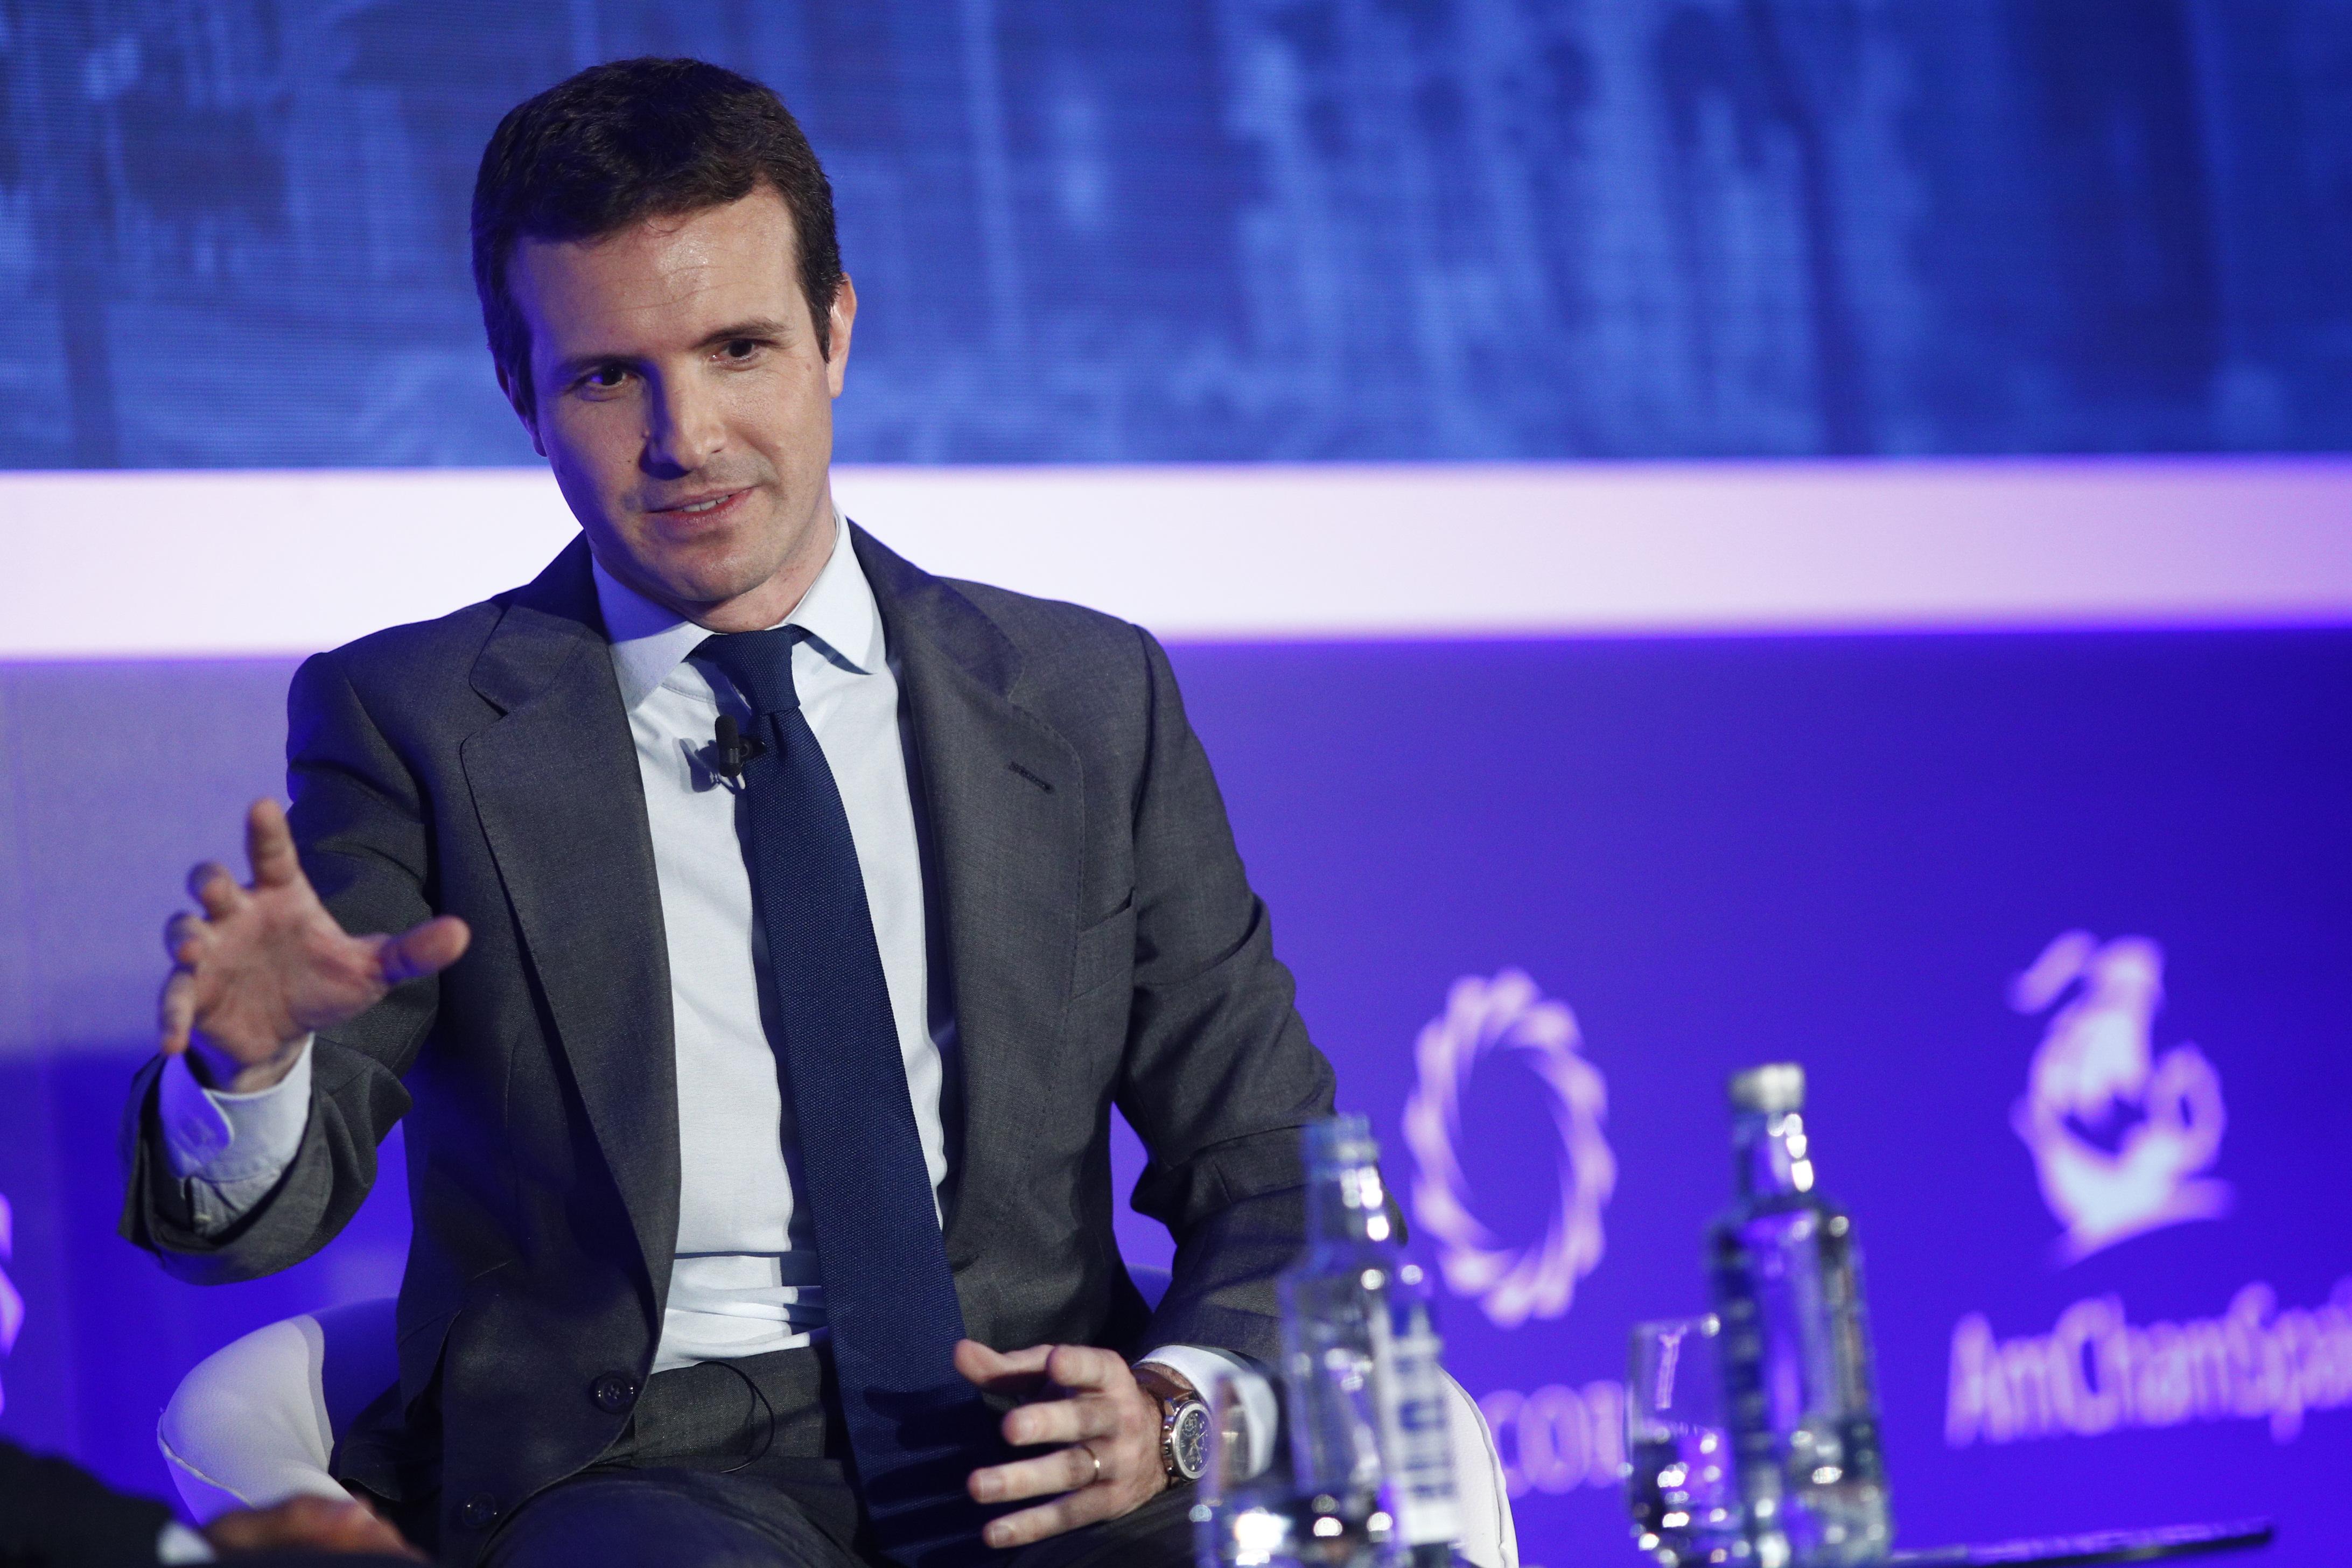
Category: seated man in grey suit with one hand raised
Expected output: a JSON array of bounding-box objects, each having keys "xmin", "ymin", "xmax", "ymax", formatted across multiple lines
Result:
[{"xmin": 125, "ymin": 61, "xmax": 1331, "ymax": 1566}]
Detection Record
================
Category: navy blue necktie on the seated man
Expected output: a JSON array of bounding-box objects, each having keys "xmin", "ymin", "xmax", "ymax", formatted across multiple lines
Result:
[{"xmin": 694, "ymin": 625, "xmax": 1002, "ymax": 1566}]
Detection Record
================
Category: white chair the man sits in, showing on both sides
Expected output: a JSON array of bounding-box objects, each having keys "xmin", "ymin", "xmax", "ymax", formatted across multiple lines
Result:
[{"xmin": 155, "ymin": 1270, "xmax": 1520, "ymax": 1568}]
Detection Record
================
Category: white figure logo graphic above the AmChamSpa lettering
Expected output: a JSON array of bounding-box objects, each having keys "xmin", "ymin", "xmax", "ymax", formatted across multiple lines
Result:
[{"xmin": 2008, "ymin": 931, "xmax": 2230, "ymax": 1267}]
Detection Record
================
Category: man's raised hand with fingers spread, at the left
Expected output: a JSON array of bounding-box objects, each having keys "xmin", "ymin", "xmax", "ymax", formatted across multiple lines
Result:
[{"xmin": 160, "ymin": 799, "xmax": 473, "ymax": 1093}]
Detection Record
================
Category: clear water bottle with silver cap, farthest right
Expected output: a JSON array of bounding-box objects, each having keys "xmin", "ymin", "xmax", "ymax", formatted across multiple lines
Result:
[{"xmin": 1707, "ymin": 1065, "xmax": 1893, "ymax": 1568}]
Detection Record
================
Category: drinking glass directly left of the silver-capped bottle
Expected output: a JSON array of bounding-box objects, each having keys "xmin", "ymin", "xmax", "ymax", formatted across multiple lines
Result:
[{"xmin": 1625, "ymin": 1314, "xmax": 1747, "ymax": 1568}]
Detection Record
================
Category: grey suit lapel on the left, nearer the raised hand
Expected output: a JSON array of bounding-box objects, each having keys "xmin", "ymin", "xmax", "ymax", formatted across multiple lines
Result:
[{"xmin": 459, "ymin": 538, "xmax": 677, "ymax": 1324}]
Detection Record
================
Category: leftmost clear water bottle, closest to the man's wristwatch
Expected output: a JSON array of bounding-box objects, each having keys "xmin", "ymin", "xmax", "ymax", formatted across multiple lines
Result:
[{"xmin": 1279, "ymin": 1117, "xmax": 1397, "ymax": 1568}]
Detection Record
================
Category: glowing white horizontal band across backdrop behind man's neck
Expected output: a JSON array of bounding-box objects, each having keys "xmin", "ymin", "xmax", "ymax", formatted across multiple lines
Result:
[{"xmin": 0, "ymin": 458, "xmax": 2352, "ymax": 661}]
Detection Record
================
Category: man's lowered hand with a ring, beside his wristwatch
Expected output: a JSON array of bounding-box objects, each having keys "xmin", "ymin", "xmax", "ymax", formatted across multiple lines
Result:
[{"xmin": 955, "ymin": 1340, "xmax": 1169, "ymax": 1547}]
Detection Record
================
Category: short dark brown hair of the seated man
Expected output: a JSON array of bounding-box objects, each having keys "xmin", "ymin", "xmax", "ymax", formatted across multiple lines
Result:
[{"xmin": 473, "ymin": 59, "xmax": 842, "ymax": 416}]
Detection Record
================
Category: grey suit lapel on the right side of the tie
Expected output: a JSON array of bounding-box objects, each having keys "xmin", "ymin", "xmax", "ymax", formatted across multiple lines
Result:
[{"xmin": 851, "ymin": 529, "xmax": 1084, "ymax": 1267}]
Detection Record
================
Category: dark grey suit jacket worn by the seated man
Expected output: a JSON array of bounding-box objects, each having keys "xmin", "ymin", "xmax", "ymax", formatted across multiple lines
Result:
[{"xmin": 122, "ymin": 529, "xmax": 1331, "ymax": 1561}]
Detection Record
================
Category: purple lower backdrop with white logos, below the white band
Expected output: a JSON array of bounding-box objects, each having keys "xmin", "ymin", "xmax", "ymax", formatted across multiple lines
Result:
[{"xmin": 0, "ymin": 632, "xmax": 2352, "ymax": 1568}]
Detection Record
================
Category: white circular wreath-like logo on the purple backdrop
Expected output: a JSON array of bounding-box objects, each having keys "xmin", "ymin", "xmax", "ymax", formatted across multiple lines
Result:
[{"xmin": 1404, "ymin": 969, "xmax": 1616, "ymax": 1328}]
